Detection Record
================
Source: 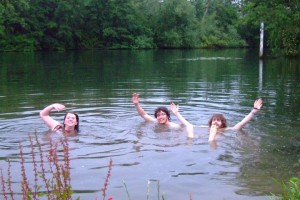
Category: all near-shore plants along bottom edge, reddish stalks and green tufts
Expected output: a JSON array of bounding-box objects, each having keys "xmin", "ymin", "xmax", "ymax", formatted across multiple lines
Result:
[{"xmin": 0, "ymin": 133, "xmax": 300, "ymax": 200}]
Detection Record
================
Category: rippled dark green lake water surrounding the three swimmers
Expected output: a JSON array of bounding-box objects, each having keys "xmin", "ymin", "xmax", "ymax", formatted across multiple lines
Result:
[{"xmin": 0, "ymin": 50, "xmax": 300, "ymax": 200}]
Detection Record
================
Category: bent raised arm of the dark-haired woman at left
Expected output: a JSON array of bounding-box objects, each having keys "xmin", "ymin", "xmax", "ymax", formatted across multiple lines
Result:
[{"xmin": 40, "ymin": 103, "xmax": 65, "ymax": 130}]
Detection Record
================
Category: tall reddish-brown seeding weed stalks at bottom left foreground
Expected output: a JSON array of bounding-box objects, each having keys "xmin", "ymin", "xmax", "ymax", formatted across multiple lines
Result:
[{"xmin": 0, "ymin": 134, "xmax": 112, "ymax": 200}]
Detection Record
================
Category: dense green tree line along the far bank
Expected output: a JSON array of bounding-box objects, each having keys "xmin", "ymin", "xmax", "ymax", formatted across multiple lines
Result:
[{"xmin": 0, "ymin": 0, "xmax": 300, "ymax": 56}]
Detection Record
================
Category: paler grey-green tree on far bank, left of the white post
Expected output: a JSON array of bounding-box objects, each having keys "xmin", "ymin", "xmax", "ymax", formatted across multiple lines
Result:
[{"xmin": 197, "ymin": 0, "xmax": 246, "ymax": 48}]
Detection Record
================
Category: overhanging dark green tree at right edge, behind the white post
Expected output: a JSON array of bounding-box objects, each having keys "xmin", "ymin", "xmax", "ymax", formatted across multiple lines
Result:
[{"xmin": 240, "ymin": 0, "xmax": 300, "ymax": 56}]
